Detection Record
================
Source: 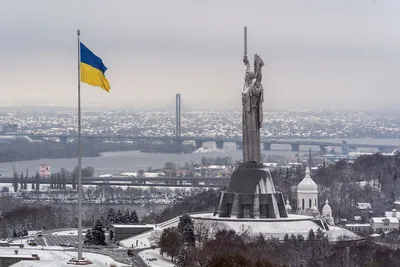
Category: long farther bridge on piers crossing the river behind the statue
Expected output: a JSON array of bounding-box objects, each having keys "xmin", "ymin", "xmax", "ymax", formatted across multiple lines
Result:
[{"xmin": 0, "ymin": 133, "xmax": 400, "ymax": 152}]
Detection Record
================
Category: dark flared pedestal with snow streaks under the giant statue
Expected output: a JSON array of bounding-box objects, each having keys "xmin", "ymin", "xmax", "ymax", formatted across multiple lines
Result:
[{"xmin": 214, "ymin": 162, "xmax": 288, "ymax": 219}]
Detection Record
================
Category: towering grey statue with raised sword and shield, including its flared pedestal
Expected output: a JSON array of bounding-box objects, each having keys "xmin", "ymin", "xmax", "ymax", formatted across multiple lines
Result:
[{"xmin": 214, "ymin": 27, "xmax": 288, "ymax": 219}]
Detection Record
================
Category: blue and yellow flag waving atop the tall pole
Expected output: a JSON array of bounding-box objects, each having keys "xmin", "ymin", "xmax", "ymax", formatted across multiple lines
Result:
[{"xmin": 80, "ymin": 43, "xmax": 110, "ymax": 92}]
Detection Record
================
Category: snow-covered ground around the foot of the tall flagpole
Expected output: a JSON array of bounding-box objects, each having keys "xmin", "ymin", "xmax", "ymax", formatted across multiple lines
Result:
[{"xmin": 0, "ymin": 248, "xmax": 127, "ymax": 267}]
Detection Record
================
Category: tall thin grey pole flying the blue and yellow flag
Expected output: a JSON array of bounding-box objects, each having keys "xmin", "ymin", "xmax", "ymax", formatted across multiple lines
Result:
[{"xmin": 77, "ymin": 30, "xmax": 82, "ymax": 260}]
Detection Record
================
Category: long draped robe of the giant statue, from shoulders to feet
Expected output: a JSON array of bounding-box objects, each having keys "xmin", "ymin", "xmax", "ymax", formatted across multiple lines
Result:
[{"xmin": 242, "ymin": 81, "xmax": 264, "ymax": 162}]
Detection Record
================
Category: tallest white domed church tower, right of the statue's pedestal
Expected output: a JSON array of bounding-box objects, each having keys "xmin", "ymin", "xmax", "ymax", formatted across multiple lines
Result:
[{"xmin": 297, "ymin": 167, "xmax": 318, "ymax": 211}]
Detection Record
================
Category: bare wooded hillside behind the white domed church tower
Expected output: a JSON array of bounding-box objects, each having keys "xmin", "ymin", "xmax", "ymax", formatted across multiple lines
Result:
[{"xmin": 271, "ymin": 154, "xmax": 400, "ymax": 223}]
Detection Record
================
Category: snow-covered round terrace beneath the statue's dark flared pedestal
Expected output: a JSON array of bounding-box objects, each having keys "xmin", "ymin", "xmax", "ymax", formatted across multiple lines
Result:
[{"xmin": 190, "ymin": 213, "xmax": 362, "ymax": 242}]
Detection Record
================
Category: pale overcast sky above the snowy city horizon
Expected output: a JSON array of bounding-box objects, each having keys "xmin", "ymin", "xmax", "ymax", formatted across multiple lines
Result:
[{"xmin": 0, "ymin": 0, "xmax": 400, "ymax": 109}]
